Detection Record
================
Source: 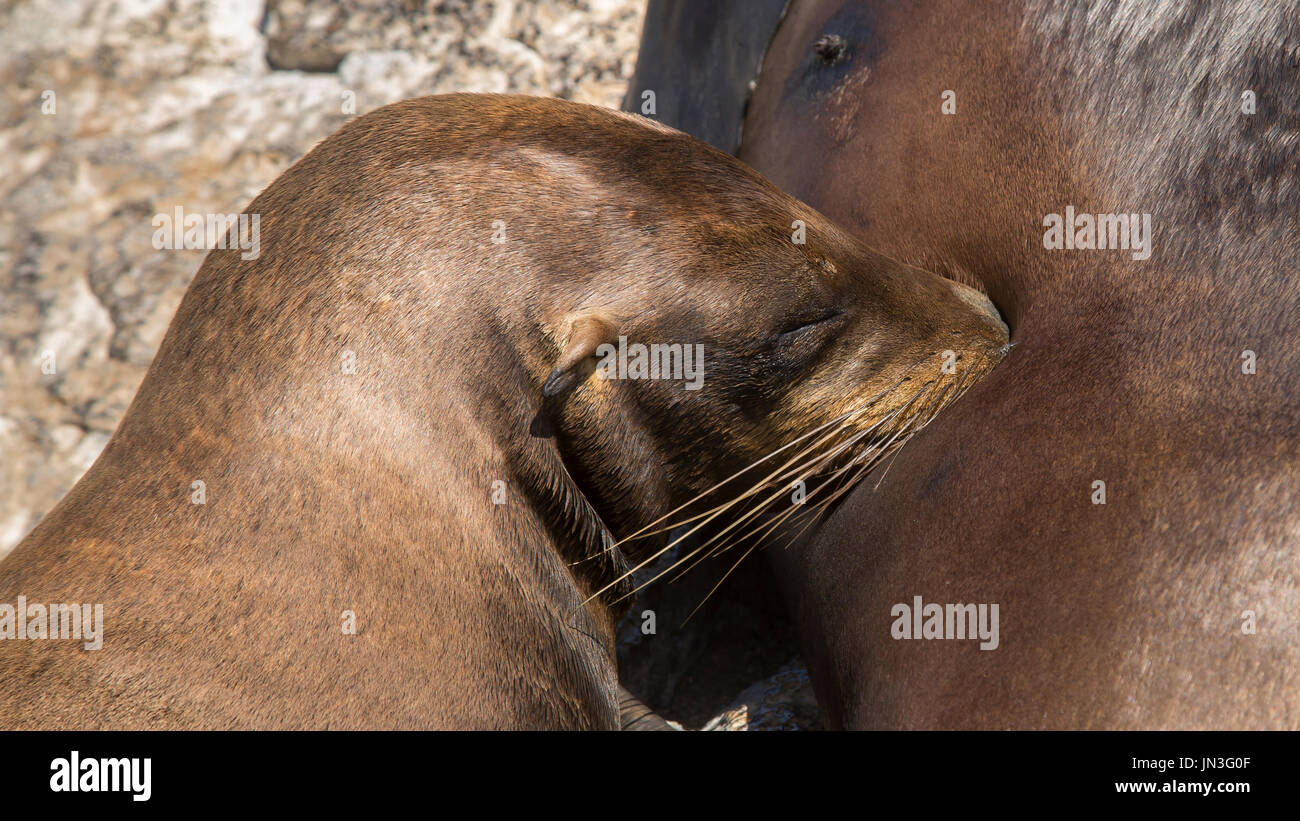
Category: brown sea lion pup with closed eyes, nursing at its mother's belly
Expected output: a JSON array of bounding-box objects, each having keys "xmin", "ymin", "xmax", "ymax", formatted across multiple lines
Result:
[{"xmin": 0, "ymin": 95, "xmax": 1006, "ymax": 729}]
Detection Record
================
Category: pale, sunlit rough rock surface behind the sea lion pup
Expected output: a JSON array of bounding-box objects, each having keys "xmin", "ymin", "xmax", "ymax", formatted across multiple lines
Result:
[{"xmin": 0, "ymin": 0, "xmax": 811, "ymax": 726}]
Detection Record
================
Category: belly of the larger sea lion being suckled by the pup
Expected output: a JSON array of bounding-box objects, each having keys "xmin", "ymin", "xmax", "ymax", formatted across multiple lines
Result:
[{"xmin": 702, "ymin": 0, "xmax": 1300, "ymax": 729}]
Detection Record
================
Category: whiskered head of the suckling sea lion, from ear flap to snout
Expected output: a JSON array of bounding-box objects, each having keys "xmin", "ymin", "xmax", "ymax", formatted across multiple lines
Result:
[{"xmin": 522, "ymin": 102, "xmax": 1008, "ymax": 561}]
